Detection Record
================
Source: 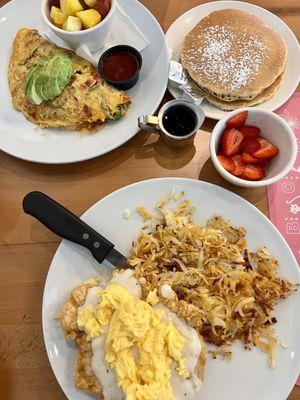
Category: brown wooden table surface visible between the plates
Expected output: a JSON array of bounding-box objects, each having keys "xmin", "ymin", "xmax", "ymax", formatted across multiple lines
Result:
[{"xmin": 0, "ymin": 0, "xmax": 300, "ymax": 400}]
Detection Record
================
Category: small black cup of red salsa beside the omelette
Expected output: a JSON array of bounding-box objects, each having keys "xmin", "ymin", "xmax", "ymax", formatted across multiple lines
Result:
[{"xmin": 98, "ymin": 45, "xmax": 143, "ymax": 90}]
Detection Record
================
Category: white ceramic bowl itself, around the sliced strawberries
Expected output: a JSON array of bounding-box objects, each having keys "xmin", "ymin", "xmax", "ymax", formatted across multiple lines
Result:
[{"xmin": 210, "ymin": 107, "xmax": 297, "ymax": 187}]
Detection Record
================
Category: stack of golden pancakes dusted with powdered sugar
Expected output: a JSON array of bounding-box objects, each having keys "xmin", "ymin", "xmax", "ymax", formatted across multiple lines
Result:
[{"xmin": 181, "ymin": 9, "xmax": 287, "ymax": 110}]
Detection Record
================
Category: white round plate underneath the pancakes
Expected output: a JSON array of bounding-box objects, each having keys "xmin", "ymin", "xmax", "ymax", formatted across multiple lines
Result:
[{"xmin": 166, "ymin": 1, "xmax": 300, "ymax": 120}]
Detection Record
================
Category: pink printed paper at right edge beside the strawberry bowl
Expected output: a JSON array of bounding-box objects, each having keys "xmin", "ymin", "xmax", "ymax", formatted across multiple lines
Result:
[{"xmin": 267, "ymin": 93, "xmax": 300, "ymax": 264}]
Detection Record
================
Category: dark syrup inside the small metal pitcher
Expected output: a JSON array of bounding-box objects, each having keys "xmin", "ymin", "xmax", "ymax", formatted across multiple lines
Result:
[{"xmin": 162, "ymin": 105, "xmax": 197, "ymax": 136}]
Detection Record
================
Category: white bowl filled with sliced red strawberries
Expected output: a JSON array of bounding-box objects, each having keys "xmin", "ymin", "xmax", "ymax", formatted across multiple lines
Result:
[{"xmin": 210, "ymin": 108, "xmax": 297, "ymax": 187}]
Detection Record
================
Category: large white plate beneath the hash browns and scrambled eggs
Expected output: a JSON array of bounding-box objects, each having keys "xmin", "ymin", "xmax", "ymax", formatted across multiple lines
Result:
[{"xmin": 43, "ymin": 178, "xmax": 300, "ymax": 400}]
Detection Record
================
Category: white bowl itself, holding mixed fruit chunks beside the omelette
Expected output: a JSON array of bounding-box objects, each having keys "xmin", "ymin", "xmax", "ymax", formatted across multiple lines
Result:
[{"xmin": 41, "ymin": 0, "xmax": 117, "ymax": 52}]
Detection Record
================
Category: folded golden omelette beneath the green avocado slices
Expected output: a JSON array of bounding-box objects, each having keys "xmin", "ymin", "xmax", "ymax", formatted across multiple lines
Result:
[{"xmin": 8, "ymin": 28, "xmax": 130, "ymax": 131}]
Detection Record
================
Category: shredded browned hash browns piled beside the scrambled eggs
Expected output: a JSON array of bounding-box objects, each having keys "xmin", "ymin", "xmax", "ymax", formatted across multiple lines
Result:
[{"xmin": 129, "ymin": 193, "xmax": 295, "ymax": 367}]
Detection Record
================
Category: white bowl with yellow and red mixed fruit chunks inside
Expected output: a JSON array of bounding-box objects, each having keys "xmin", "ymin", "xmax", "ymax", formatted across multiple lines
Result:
[{"xmin": 41, "ymin": 0, "xmax": 116, "ymax": 51}]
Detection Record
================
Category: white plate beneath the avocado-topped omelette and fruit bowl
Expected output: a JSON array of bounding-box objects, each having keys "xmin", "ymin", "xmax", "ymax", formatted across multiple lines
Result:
[{"xmin": 0, "ymin": 0, "xmax": 169, "ymax": 164}]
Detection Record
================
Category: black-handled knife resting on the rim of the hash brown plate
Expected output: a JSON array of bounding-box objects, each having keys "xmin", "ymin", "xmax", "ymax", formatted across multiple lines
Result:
[{"xmin": 23, "ymin": 192, "xmax": 130, "ymax": 268}]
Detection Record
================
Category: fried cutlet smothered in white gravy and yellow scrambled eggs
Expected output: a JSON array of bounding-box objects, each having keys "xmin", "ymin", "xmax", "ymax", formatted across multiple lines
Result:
[{"xmin": 57, "ymin": 269, "xmax": 205, "ymax": 400}]
